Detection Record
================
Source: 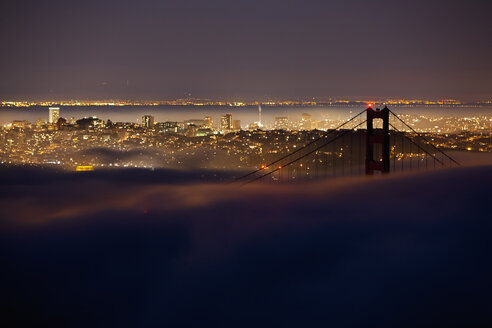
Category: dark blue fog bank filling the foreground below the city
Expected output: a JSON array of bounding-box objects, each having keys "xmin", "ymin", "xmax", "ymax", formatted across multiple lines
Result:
[{"xmin": 0, "ymin": 166, "xmax": 492, "ymax": 327}]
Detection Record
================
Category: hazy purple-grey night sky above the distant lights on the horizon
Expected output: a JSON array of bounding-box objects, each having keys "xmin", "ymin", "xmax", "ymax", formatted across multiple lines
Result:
[{"xmin": 0, "ymin": 0, "xmax": 492, "ymax": 100}]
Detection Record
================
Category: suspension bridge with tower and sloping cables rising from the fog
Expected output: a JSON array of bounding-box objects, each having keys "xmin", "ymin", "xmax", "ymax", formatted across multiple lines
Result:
[{"xmin": 233, "ymin": 106, "xmax": 460, "ymax": 185}]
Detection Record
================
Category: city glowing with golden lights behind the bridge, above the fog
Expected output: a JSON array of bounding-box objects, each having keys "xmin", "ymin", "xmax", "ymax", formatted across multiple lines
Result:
[{"xmin": 0, "ymin": 105, "xmax": 492, "ymax": 172}]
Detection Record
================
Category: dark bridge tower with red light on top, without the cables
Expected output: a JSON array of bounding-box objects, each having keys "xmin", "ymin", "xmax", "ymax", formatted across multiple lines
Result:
[{"xmin": 366, "ymin": 106, "xmax": 390, "ymax": 175}]
